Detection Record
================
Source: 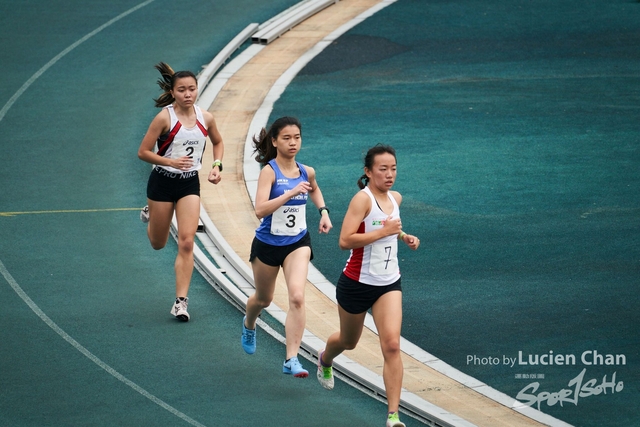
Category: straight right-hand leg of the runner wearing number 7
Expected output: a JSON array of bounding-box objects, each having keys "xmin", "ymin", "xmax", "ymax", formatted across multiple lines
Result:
[{"xmin": 372, "ymin": 291, "xmax": 403, "ymax": 412}]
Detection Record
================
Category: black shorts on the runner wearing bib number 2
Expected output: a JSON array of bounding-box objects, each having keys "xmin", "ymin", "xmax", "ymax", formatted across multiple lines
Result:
[{"xmin": 147, "ymin": 166, "xmax": 200, "ymax": 203}]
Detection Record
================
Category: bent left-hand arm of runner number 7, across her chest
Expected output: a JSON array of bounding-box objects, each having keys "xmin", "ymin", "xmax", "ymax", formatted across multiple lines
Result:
[{"xmin": 339, "ymin": 192, "xmax": 402, "ymax": 249}]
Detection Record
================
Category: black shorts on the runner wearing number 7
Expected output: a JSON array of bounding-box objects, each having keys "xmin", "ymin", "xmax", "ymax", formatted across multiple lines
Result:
[{"xmin": 336, "ymin": 273, "xmax": 402, "ymax": 314}]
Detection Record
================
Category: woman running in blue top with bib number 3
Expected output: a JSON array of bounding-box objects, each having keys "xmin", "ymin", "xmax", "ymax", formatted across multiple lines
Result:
[{"xmin": 241, "ymin": 117, "xmax": 332, "ymax": 378}]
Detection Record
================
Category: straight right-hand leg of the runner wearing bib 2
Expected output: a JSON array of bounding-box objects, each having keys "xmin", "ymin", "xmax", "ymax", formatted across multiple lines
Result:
[{"xmin": 175, "ymin": 195, "xmax": 200, "ymax": 297}]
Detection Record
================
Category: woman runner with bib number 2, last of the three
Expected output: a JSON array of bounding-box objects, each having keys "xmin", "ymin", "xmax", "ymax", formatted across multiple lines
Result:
[{"xmin": 138, "ymin": 62, "xmax": 224, "ymax": 322}]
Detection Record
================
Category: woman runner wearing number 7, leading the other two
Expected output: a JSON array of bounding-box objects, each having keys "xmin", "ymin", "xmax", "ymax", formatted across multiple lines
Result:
[{"xmin": 317, "ymin": 145, "xmax": 420, "ymax": 427}]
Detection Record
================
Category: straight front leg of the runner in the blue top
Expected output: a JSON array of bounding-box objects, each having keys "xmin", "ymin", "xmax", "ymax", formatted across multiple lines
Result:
[{"xmin": 282, "ymin": 246, "xmax": 311, "ymax": 359}]
